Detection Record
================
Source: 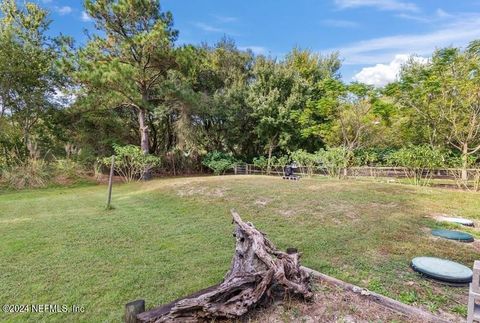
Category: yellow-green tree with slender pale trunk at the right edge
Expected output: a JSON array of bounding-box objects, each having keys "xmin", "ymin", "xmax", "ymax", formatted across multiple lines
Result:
[{"xmin": 389, "ymin": 42, "xmax": 480, "ymax": 180}]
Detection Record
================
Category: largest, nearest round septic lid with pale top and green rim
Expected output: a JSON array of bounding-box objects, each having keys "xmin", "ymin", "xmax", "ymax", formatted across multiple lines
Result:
[{"xmin": 412, "ymin": 257, "xmax": 473, "ymax": 283}]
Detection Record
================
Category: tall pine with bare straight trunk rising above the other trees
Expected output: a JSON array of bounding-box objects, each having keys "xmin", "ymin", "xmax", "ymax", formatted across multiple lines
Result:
[{"xmin": 75, "ymin": 0, "xmax": 178, "ymax": 154}]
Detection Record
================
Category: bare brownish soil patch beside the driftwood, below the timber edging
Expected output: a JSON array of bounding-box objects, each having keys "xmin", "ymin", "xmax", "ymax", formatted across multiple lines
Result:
[{"xmin": 237, "ymin": 281, "xmax": 461, "ymax": 323}]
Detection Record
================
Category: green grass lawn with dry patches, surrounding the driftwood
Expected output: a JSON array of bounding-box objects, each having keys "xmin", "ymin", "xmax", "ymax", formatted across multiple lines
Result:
[{"xmin": 0, "ymin": 176, "xmax": 480, "ymax": 322}]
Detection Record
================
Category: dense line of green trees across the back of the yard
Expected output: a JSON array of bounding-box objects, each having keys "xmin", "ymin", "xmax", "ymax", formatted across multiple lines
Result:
[{"xmin": 0, "ymin": 0, "xmax": 480, "ymax": 189}]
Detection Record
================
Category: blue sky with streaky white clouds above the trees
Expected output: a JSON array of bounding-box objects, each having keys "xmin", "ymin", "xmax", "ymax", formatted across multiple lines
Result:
[{"xmin": 38, "ymin": 0, "xmax": 480, "ymax": 86}]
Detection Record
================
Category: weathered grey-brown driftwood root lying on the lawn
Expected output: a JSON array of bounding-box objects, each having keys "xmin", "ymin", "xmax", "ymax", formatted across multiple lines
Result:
[{"xmin": 138, "ymin": 210, "xmax": 313, "ymax": 322}]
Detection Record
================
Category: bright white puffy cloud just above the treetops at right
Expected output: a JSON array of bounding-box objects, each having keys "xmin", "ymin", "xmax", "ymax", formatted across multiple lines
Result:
[{"xmin": 353, "ymin": 54, "xmax": 428, "ymax": 87}]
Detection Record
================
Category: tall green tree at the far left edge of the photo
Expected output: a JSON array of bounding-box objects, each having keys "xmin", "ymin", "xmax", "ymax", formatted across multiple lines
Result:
[{"xmin": 0, "ymin": 0, "xmax": 60, "ymax": 157}]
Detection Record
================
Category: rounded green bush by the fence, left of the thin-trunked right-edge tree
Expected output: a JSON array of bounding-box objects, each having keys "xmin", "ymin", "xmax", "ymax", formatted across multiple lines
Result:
[{"xmin": 388, "ymin": 145, "xmax": 446, "ymax": 185}]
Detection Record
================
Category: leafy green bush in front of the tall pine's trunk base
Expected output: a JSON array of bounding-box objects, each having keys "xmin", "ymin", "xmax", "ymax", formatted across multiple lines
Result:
[{"xmin": 102, "ymin": 145, "xmax": 160, "ymax": 183}]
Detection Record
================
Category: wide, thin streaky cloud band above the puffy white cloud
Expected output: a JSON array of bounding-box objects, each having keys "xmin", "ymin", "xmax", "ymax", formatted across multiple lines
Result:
[{"xmin": 327, "ymin": 14, "xmax": 480, "ymax": 65}]
